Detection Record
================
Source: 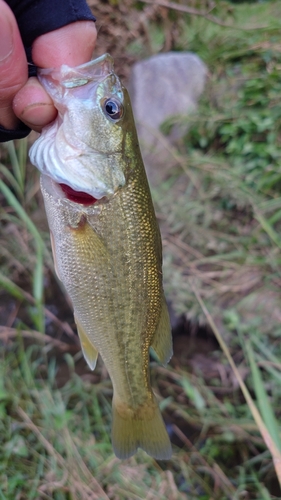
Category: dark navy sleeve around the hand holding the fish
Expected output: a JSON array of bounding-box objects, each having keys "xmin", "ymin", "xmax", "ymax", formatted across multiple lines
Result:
[{"xmin": 0, "ymin": 0, "xmax": 95, "ymax": 142}]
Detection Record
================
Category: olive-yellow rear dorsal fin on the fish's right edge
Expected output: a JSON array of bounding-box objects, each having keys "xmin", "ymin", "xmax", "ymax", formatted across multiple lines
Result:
[{"xmin": 151, "ymin": 299, "xmax": 173, "ymax": 365}]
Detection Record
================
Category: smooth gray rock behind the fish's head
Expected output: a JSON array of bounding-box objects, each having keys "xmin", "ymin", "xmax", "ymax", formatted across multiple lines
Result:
[{"xmin": 128, "ymin": 52, "xmax": 207, "ymax": 184}]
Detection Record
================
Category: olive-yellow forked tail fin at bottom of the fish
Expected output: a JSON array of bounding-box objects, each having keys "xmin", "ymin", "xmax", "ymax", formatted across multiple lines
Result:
[{"xmin": 112, "ymin": 394, "xmax": 172, "ymax": 460}]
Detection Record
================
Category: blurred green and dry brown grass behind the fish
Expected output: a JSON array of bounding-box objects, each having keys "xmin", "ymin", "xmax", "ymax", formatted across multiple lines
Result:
[{"xmin": 0, "ymin": 0, "xmax": 281, "ymax": 500}]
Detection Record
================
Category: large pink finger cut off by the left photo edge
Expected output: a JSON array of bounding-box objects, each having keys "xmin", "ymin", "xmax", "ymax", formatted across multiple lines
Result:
[{"xmin": 0, "ymin": 0, "xmax": 28, "ymax": 129}]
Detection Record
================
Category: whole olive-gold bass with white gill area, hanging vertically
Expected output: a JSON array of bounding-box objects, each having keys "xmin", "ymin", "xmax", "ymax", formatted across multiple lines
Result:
[{"xmin": 30, "ymin": 54, "xmax": 172, "ymax": 460}]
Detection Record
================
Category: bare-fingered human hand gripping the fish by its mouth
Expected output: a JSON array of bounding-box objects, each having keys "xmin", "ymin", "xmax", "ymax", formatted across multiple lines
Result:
[{"xmin": 0, "ymin": 0, "xmax": 97, "ymax": 132}]
